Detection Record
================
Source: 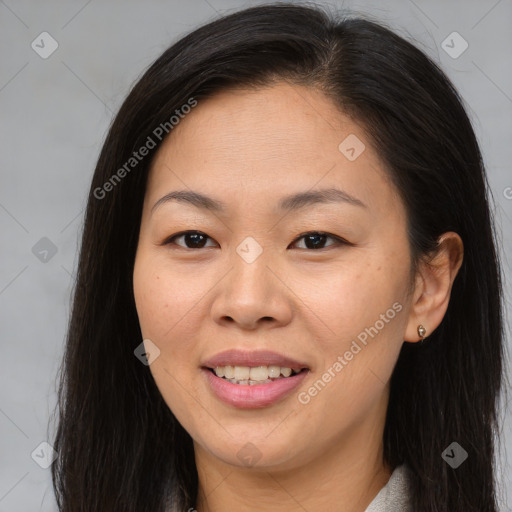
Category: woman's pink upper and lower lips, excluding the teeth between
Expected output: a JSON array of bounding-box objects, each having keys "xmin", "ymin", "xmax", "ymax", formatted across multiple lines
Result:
[{"xmin": 202, "ymin": 349, "xmax": 309, "ymax": 409}]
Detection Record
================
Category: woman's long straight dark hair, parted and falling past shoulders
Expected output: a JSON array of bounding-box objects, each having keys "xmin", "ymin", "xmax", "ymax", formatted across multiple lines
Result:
[{"xmin": 52, "ymin": 3, "xmax": 504, "ymax": 512}]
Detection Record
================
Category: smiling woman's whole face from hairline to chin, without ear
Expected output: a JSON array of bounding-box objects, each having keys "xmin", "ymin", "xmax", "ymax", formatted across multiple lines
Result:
[{"xmin": 134, "ymin": 82, "xmax": 411, "ymax": 469}]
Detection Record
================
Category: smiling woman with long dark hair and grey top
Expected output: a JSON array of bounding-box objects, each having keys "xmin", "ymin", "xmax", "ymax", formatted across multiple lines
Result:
[{"xmin": 52, "ymin": 4, "xmax": 503, "ymax": 512}]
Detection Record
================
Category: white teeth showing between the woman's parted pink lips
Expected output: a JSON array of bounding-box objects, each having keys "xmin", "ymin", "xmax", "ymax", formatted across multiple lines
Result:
[{"xmin": 203, "ymin": 365, "xmax": 309, "ymax": 386}]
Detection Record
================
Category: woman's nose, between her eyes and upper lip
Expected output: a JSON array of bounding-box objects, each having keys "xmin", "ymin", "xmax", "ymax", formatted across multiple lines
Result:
[{"xmin": 212, "ymin": 247, "xmax": 293, "ymax": 330}]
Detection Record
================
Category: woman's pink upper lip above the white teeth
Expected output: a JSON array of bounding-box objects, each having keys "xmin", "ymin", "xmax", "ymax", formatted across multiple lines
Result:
[{"xmin": 202, "ymin": 349, "xmax": 309, "ymax": 371}]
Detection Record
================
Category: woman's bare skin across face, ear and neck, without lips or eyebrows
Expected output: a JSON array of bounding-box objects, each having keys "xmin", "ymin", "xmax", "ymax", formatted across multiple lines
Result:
[{"xmin": 133, "ymin": 82, "xmax": 463, "ymax": 512}]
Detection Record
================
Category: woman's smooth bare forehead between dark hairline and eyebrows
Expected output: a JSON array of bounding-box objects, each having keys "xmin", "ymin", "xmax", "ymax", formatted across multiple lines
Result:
[{"xmin": 147, "ymin": 82, "xmax": 397, "ymax": 219}]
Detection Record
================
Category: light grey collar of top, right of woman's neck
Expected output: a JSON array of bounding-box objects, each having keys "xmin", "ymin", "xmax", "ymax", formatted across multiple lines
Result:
[{"xmin": 364, "ymin": 464, "xmax": 412, "ymax": 512}]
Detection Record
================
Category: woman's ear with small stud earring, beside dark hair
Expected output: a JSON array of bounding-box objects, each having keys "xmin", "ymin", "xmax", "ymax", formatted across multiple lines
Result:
[{"xmin": 404, "ymin": 231, "xmax": 464, "ymax": 343}]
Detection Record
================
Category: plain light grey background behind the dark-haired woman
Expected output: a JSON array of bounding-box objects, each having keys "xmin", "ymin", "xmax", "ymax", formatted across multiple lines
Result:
[{"xmin": 0, "ymin": 0, "xmax": 512, "ymax": 512}]
